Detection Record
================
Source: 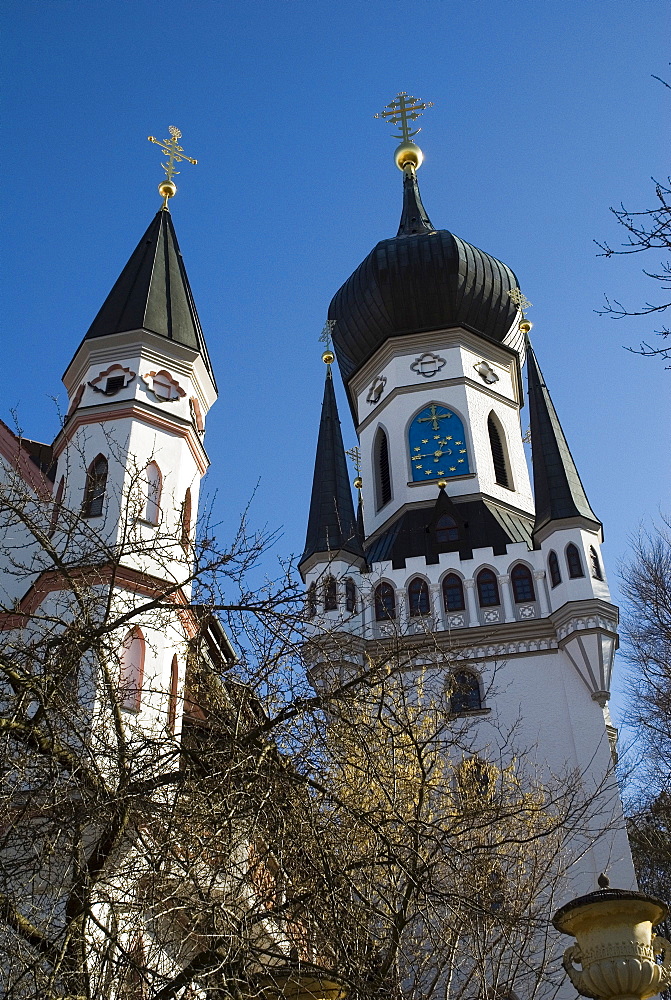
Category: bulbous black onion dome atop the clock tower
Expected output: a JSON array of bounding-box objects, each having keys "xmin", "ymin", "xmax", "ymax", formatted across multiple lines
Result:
[{"xmin": 328, "ymin": 174, "xmax": 518, "ymax": 382}]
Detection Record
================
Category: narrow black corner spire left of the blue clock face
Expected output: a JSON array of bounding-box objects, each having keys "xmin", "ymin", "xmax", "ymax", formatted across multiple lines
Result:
[{"xmin": 298, "ymin": 366, "xmax": 364, "ymax": 567}]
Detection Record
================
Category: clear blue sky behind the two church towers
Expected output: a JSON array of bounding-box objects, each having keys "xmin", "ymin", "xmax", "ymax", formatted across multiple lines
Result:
[{"xmin": 0, "ymin": 0, "xmax": 671, "ymax": 720}]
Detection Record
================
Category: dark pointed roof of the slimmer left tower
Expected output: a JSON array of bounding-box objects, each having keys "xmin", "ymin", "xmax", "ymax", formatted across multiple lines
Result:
[{"xmin": 84, "ymin": 209, "xmax": 212, "ymax": 374}]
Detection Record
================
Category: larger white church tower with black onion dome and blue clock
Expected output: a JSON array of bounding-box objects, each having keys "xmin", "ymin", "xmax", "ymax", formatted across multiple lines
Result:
[{"xmin": 300, "ymin": 94, "xmax": 634, "ymax": 891}]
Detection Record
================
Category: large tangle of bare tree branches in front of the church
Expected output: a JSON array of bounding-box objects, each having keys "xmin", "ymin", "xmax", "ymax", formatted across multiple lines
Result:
[{"xmin": 0, "ymin": 440, "xmax": 616, "ymax": 1000}]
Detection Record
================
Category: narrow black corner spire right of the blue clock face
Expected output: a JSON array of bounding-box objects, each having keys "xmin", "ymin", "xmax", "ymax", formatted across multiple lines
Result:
[{"xmin": 527, "ymin": 342, "xmax": 601, "ymax": 533}]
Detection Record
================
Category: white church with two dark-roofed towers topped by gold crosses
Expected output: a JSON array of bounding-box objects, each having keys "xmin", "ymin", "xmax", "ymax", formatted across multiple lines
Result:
[{"xmin": 0, "ymin": 95, "xmax": 635, "ymax": 996}]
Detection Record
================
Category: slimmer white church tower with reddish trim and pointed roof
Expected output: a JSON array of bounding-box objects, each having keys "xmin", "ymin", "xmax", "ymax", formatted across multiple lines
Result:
[{"xmin": 46, "ymin": 129, "xmax": 217, "ymax": 732}]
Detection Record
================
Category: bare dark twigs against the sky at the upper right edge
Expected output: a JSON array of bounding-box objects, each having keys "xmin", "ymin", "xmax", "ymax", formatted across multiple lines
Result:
[{"xmin": 595, "ymin": 76, "xmax": 671, "ymax": 361}]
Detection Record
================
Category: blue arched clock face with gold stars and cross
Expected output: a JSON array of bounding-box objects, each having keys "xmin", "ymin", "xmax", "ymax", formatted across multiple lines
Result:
[{"xmin": 408, "ymin": 403, "xmax": 471, "ymax": 483}]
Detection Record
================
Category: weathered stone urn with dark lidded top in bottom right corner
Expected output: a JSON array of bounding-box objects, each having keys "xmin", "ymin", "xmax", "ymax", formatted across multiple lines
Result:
[{"xmin": 552, "ymin": 875, "xmax": 671, "ymax": 1000}]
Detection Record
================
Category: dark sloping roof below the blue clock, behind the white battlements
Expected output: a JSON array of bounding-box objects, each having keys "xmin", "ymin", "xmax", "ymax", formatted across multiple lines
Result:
[{"xmin": 366, "ymin": 491, "xmax": 532, "ymax": 569}]
